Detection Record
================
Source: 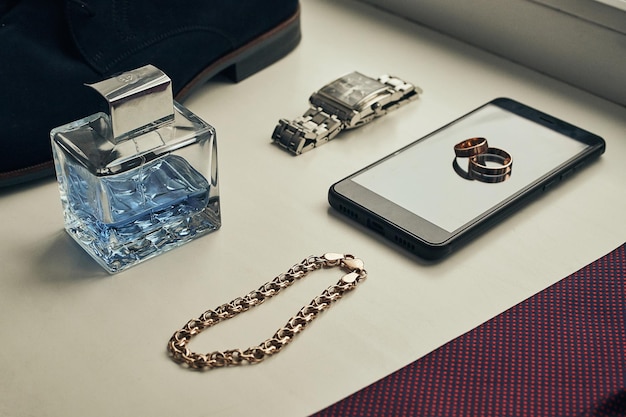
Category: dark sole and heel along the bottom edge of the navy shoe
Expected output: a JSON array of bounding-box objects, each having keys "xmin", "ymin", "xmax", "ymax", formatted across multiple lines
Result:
[{"xmin": 0, "ymin": 7, "xmax": 302, "ymax": 188}]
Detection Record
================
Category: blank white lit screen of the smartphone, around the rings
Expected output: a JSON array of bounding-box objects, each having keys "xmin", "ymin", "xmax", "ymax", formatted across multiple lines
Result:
[{"xmin": 352, "ymin": 104, "xmax": 587, "ymax": 233}]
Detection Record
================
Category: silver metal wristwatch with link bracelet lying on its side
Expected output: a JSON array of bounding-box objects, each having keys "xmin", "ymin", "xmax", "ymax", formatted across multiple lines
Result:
[{"xmin": 272, "ymin": 71, "xmax": 422, "ymax": 155}]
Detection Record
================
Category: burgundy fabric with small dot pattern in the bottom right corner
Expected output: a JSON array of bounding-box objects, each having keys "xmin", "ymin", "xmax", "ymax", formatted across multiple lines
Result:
[{"xmin": 315, "ymin": 245, "xmax": 626, "ymax": 417}]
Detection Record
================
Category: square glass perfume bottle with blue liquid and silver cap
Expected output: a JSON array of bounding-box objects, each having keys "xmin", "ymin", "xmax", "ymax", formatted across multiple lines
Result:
[{"xmin": 50, "ymin": 65, "xmax": 221, "ymax": 273}]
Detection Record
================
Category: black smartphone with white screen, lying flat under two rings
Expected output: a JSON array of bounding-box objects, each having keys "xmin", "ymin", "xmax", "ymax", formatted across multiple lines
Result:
[{"xmin": 328, "ymin": 98, "xmax": 606, "ymax": 260}]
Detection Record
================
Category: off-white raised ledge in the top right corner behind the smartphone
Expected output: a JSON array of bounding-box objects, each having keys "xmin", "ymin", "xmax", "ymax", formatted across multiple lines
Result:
[{"xmin": 362, "ymin": 0, "xmax": 626, "ymax": 105}]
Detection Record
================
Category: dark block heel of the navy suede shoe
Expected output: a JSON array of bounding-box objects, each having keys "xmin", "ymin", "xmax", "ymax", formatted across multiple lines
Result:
[{"xmin": 223, "ymin": 9, "xmax": 301, "ymax": 82}]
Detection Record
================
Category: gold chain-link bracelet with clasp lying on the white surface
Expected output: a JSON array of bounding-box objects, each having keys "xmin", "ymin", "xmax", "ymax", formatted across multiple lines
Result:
[{"xmin": 167, "ymin": 253, "xmax": 367, "ymax": 369}]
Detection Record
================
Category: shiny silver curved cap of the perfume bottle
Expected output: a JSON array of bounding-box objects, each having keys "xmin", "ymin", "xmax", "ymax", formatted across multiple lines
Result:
[{"xmin": 86, "ymin": 65, "xmax": 174, "ymax": 143}]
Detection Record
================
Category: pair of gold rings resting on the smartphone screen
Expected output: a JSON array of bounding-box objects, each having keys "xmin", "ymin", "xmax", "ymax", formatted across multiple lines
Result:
[{"xmin": 454, "ymin": 137, "xmax": 513, "ymax": 182}]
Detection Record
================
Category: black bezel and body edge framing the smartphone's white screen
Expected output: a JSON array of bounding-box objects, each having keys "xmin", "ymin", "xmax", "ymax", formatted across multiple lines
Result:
[{"xmin": 328, "ymin": 98, "xmax": 606, "ymax": 259}]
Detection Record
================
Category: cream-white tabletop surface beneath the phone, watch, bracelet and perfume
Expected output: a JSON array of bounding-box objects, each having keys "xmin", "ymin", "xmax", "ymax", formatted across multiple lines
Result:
[{"xmin": 0, "ymin": 0, "xmax": 626, "ymax": 417}]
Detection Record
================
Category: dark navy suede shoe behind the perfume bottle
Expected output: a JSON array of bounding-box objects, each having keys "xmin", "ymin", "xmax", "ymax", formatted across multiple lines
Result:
[{"xmin": 0, "ymin": 0, "xmax": 300, "ymax": 186}]
